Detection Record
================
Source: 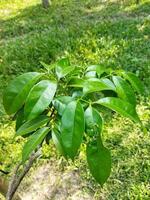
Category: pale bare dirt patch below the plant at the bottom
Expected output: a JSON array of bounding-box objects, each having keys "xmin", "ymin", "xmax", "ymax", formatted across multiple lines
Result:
[{"xmin": 18, "ymin": 161, "xmax": 93, "ymax": 200}]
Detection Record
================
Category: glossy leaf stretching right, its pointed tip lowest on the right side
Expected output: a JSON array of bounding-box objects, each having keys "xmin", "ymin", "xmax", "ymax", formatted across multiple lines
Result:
[{"xmin": 95, "ymin": 97, "xmax": 141, "ymax": 123}]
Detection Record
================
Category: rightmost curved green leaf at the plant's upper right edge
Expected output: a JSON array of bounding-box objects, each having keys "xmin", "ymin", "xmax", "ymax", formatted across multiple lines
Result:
[{"xmin": 122, "ymin": 72, "xmax": 145, "ymax": 94}]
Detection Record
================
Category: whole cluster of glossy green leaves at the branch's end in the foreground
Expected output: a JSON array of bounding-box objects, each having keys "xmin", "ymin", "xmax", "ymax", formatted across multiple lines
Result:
[{"xmin": 3, "ymin": 58, "xmax": 145, "ymax": 185}]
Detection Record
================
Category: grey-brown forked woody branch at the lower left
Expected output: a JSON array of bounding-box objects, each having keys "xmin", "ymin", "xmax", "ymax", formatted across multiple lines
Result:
[{"xmin": 6, "ymin": 149, "xmax": 41, "ymax": 200}]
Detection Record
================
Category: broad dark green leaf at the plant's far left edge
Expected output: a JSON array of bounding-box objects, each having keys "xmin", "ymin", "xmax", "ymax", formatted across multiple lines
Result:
[{"xmin": 3, "ymin": 72, "xmax": 43, "ymax": 114}]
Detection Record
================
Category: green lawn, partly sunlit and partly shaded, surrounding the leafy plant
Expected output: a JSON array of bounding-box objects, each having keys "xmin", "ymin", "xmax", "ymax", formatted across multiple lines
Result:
[{"xmin": 0, "ymin": 0, "xmax": 150, "ymax": 200}]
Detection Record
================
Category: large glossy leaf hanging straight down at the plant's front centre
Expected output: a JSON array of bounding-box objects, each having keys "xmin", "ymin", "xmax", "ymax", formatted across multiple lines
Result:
[{"xmin": 61, "ymin": 101, "xmax": 85, "ymax": 159}]
